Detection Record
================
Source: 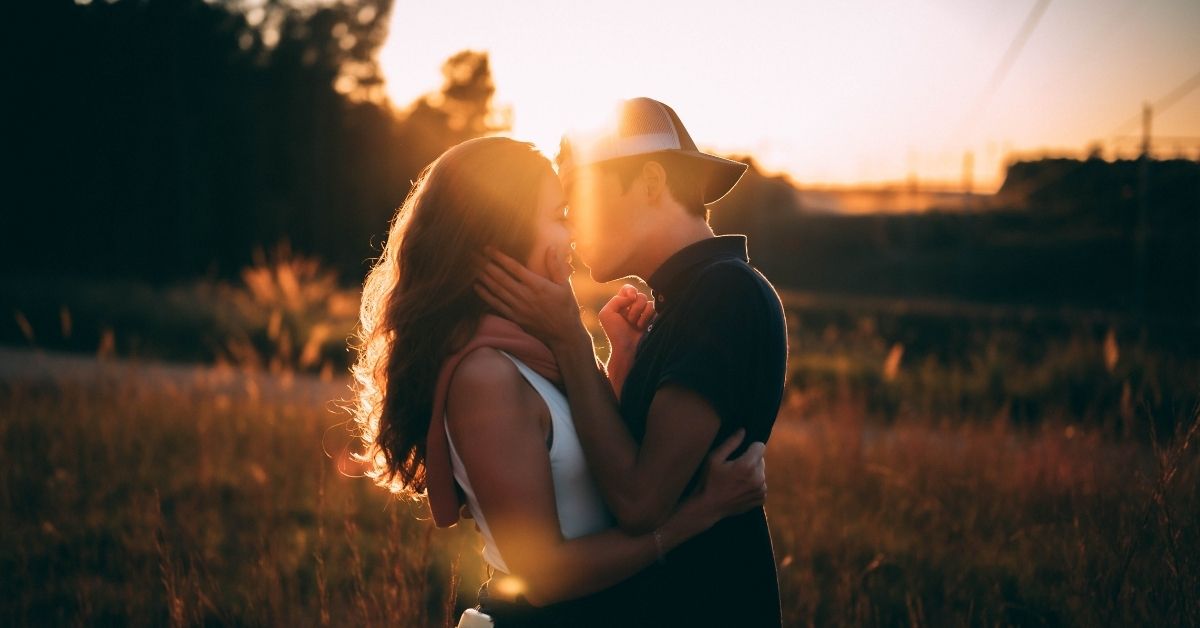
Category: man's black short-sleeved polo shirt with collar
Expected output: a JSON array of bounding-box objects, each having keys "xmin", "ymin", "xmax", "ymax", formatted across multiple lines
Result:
[{"xmin": 620, "ymin": 235, "xmax": 787, "ymax": 627}]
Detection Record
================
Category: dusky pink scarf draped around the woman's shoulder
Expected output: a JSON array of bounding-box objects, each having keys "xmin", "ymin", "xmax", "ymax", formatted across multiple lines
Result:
[{"xmin": 425, "ymin": 315, "xmax": 562, "ymax": 527}]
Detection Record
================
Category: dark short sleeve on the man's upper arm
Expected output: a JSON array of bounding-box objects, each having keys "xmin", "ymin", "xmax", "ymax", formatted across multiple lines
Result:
[{"xmin": 658, "ymin": 267, "xmax": 766, "ymax": 439}]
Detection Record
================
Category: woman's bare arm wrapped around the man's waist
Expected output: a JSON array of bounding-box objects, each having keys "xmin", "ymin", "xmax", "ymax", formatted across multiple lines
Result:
[{"xmin": 446, "ymin": 349, "xmax": 764, "ymax": 605}]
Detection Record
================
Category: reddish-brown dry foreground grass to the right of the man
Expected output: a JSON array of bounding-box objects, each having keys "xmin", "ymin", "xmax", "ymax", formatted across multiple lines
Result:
[{"xmin": 768, "ymin": 400, "xmax": 1200, "ymax": 626}]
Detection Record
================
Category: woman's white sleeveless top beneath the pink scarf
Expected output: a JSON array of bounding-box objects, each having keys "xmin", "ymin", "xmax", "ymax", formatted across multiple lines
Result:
[{"xmin": 443, "ymin": 351, "xmax": 613, "ymax": 573}]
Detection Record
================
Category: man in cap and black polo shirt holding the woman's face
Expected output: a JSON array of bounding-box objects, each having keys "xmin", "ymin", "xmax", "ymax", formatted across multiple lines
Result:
[{"xmin": 481, "ymin": 98, "xmax": 787, "ymax": 626}]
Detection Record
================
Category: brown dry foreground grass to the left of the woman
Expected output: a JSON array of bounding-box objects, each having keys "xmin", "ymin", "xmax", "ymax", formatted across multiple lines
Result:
[{"xmin": 0, "ymin": 365, "xmax": 481, "ymax": 626}]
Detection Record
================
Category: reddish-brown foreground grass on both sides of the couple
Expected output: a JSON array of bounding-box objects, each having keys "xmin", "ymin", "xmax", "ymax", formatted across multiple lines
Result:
[{"xmin": 0, "ymin": 352, "xmax": 1200, "ymax": 626}]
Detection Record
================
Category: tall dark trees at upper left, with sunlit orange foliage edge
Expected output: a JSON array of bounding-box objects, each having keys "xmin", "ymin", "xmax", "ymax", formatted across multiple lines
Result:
[{"xmin": 0, "ymin": 0, "xmax": 494, "ymax": 280}]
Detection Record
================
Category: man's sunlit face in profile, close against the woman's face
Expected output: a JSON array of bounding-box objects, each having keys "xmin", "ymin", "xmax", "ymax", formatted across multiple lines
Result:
[{"xmin": 563, "ymin": 166, "xmax": 640, "ymax": 282}]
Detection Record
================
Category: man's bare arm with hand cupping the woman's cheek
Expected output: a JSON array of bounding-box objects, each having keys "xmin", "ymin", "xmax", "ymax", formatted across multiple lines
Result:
[{"xmin": 475, "ymin": 250, "xmax": 745, "ymax": 531}]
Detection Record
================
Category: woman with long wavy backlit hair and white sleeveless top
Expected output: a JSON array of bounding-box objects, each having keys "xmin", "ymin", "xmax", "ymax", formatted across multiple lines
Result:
[{"xmin": 354, "ymin": 138, "xmax": 763, "ymax": 627}]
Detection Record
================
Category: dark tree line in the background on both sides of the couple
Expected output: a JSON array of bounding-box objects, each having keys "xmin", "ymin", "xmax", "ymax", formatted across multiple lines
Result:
[{"xmin": 9, "ymin": 0, "xmax": 1200, "ymax": 321}]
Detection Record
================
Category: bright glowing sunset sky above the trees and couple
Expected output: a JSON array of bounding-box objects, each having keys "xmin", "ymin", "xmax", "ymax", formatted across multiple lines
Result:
[{"xmin": 382, "ymin": 0, "xmax": 1200, "ymax": 187}]
